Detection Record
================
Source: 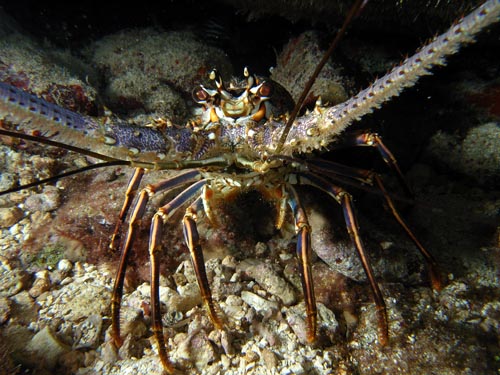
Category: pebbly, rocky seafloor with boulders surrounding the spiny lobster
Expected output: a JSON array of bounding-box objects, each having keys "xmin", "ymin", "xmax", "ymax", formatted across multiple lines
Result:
[{"xmin": 0, "ymin": 0, "xmax": 500, "ymax": 375}]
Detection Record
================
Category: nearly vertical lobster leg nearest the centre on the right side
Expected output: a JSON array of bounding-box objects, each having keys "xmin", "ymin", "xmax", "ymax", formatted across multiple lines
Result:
[{"xmin": 286, "ymin": 184, "xmax": 317, "ymax": 343}]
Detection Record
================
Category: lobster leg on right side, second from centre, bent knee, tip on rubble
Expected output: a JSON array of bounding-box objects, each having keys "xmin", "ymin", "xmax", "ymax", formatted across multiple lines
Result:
[{"xmin": 295, "ymin": 173, "xmax": 389, "ymax": 345}]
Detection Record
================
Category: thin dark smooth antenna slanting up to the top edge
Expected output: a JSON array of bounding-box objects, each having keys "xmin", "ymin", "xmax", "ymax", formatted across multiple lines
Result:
[{"xmin": 275, "ymin": 0, "xmax": 368, "ymax": 154}]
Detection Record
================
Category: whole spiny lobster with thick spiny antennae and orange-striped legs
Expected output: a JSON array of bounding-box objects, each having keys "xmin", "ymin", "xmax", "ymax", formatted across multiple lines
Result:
[{"xmin": 0, "ymin": 0, "xmax": 500, "ymax": 373}]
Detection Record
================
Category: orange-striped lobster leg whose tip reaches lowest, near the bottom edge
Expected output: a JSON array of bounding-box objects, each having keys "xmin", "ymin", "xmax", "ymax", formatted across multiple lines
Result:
[{"xmin": 149, "ymin": 180, "xmax": 207, "ymax": 374}]
